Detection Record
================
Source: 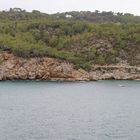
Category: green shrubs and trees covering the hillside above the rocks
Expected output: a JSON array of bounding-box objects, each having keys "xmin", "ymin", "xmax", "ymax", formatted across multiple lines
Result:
[{"xmin": 0, "ymin": 8, "xmax": 140, "ymax": 69}]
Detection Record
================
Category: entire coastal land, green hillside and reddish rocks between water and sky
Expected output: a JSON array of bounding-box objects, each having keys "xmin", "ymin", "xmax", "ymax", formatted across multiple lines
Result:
[{"xmin": 0, "ymin": 8, "xmax": 140, "ymax": 81}]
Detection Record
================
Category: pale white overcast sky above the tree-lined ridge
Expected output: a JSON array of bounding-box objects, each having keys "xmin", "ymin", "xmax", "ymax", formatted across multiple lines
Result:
[{"xmin": 0, "ymin": 0, "xmax": 140, "ymax": 15}]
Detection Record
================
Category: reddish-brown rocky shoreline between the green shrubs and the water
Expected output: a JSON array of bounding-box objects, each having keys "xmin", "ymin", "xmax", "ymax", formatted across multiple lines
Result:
[{"xmin": 0, "ymin": 52, "xmax": 140, "ymax": 81}]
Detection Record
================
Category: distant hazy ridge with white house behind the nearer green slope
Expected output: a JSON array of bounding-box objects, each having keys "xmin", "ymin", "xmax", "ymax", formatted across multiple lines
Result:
[{"xmin": 52, "ymin": 10, "xmax": 140, "ymax": 24}]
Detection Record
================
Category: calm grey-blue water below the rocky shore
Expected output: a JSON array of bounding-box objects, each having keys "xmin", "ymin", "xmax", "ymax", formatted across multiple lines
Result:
[{"xmin": 0, "ymin": 81, "xmax": 140, "ymax": 140}]
